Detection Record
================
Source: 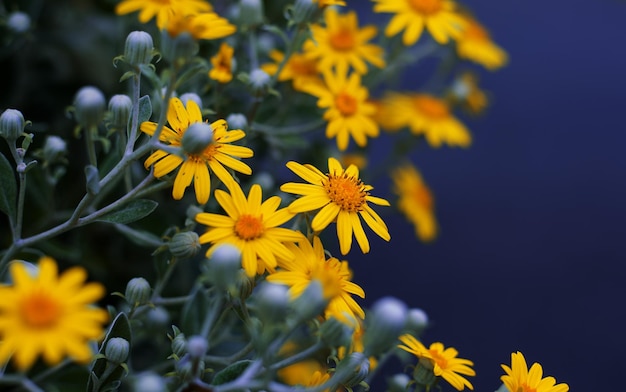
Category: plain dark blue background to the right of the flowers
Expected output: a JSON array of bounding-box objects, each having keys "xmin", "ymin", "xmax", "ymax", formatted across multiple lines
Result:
[{"xmin": 351, "ymin": 0, "xmax": 626, "ymax": 391}]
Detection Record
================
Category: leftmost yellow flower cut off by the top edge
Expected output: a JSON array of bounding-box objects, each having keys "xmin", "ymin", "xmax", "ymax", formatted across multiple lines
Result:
[{"xmin": 115, "ymin": 0, "xmax": 212, "ymax": 29}]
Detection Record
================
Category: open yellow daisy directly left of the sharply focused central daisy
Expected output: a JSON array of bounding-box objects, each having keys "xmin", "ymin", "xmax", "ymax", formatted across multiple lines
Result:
[{"xmin": 196, "ymin": 183, "xmax": 302, "ymax": 277}]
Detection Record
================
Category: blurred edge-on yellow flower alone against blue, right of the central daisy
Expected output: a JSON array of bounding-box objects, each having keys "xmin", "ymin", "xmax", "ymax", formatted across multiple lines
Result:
[{"xmin": 391, "ymin": 164, "xmax": 437, "ymax": 242}]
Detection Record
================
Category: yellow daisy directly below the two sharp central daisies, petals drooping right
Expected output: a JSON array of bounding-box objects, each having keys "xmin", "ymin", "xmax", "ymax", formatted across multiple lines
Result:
[{"xmin": 267, "ymin": 236, "xmax": 365, "ymax": 327}]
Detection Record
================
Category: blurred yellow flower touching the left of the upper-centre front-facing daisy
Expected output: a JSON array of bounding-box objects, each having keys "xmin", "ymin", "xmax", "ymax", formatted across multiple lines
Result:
[{"xmin": 261, "ymin": 50, "xmax": 324, "ymax": 90}]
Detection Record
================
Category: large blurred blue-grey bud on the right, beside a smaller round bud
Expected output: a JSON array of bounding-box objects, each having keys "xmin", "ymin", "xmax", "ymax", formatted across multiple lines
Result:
[{"xmin": 363, "ymin": 297, "xmax": 407, "ymax": 356}]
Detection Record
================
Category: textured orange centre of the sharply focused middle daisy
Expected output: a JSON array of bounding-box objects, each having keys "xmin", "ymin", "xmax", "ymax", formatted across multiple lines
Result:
[{"xmin": 322, "ymin": 173, "xmax": 367, "ymax": 212}]
